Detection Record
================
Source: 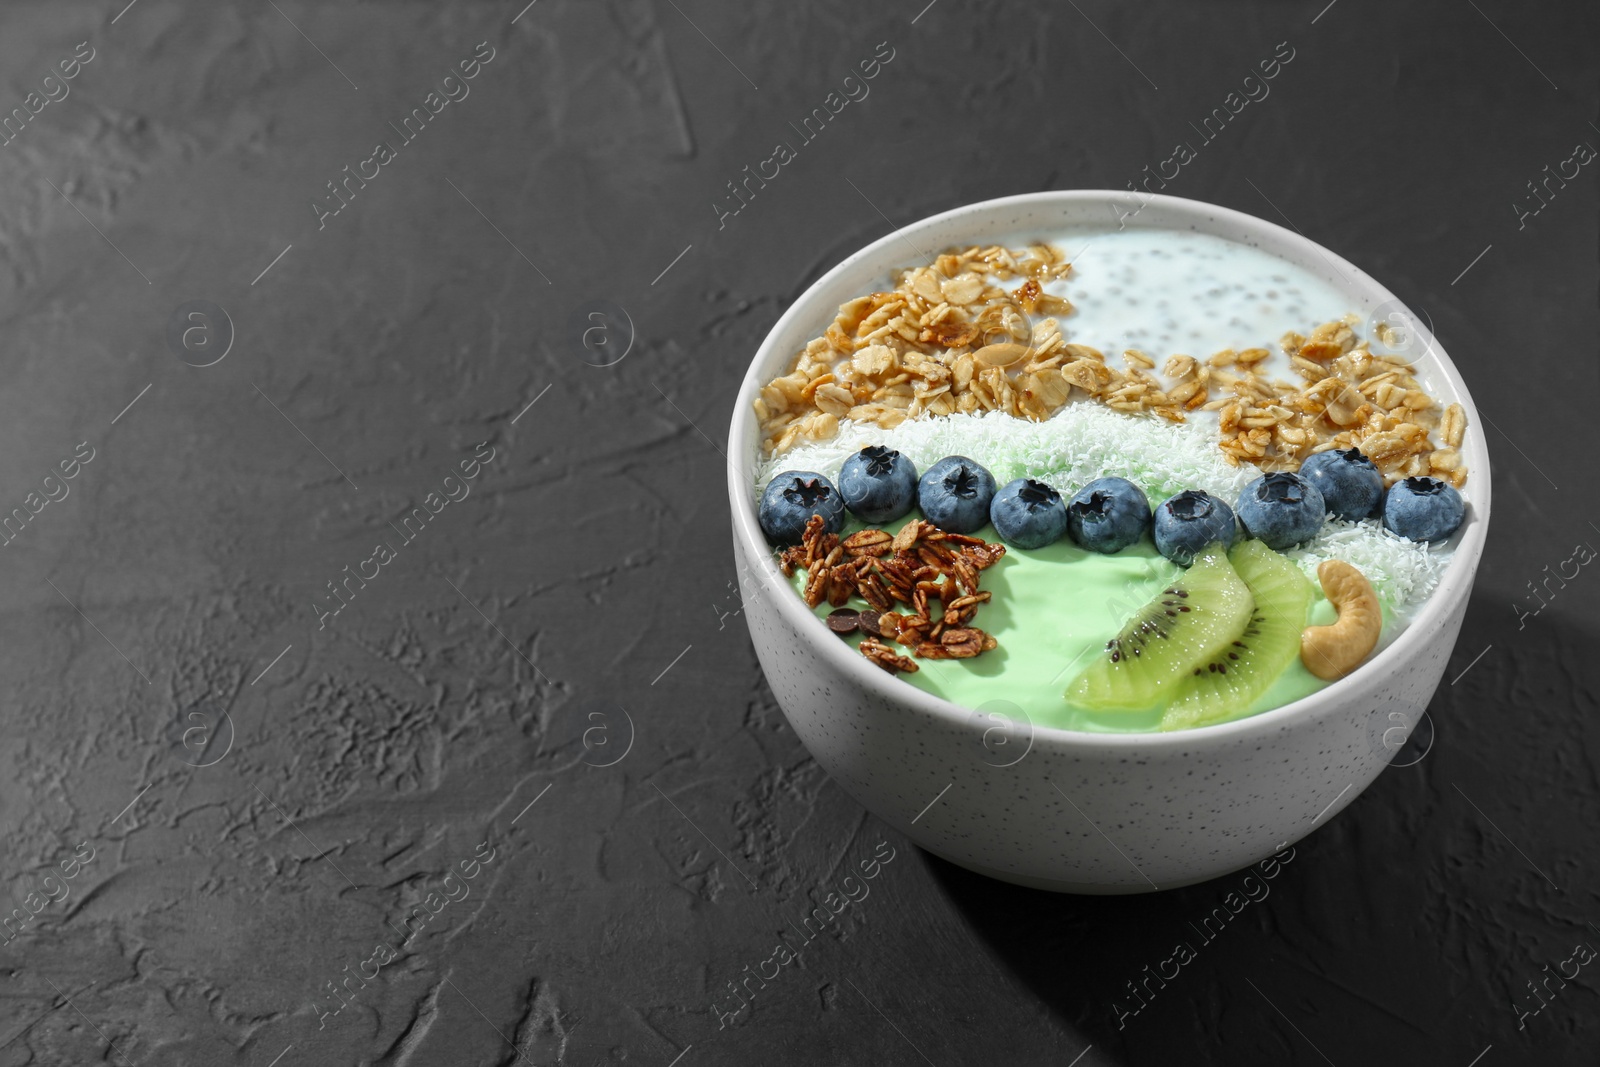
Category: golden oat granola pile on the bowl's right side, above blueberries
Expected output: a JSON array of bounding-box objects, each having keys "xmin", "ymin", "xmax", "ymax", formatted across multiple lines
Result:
[{"xmin": 1203, "ymin": 317, "xmax": 1467, "ymax": 488}]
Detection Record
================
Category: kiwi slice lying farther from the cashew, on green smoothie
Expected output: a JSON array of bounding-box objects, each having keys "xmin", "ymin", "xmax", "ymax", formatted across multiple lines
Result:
[{"xmin": 1067, "ymin": 544, "xmax": 1254, "ymax": 710}]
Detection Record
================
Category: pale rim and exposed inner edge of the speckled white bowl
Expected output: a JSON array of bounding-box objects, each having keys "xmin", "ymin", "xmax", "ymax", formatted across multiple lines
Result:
[{"xmin": 728, "ymin": 189, "xmax": 1490, "ymax": 755}]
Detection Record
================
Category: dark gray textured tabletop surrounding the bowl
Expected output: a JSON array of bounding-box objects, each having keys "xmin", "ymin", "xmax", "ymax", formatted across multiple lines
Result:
[{"xmin": 0, "ymin": 0, "xmax": 1600, "ymax": 1067}]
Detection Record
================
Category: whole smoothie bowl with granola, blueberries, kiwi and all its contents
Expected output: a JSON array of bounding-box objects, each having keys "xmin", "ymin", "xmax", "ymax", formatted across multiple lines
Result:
[{"xmin": 728, "ymin": 190, "xmax": 1490, "ymax": 893}]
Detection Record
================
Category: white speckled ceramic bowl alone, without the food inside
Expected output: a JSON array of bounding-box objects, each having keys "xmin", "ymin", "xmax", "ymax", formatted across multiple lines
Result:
[{"xmin": 728, "ymin": 190, "xmax": 1490, "ymax": 893}]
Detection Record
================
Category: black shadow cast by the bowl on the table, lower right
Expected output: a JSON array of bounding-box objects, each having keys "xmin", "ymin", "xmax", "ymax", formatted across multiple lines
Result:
[{"xmin": 918, "ymin": 593, "xmax": 1600, "ymax": 1062}]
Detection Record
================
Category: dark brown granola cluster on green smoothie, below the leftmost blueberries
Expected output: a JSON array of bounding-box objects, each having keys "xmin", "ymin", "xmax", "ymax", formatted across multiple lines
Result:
[{"xmin": 778, "ymin": 515, "xmax": 1005, "ymax": 673}]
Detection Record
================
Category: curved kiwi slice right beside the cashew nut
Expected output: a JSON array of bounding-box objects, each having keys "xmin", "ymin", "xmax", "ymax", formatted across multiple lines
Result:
[{"xmin": 1162, "ymin": 541, "xmax": 1312, "ymax": 729}]
